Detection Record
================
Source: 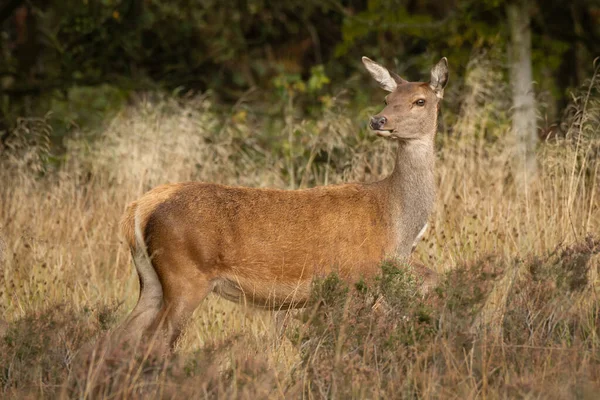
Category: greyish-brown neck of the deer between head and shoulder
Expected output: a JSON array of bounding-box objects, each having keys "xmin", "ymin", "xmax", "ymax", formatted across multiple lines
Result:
[{"xmin": 385, "ymin": 139, "xmax": 435, "ymax": 257}]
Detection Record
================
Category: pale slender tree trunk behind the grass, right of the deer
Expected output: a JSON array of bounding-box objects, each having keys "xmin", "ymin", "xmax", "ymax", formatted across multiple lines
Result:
[{"xmin": 506, "ymin": 0, "xmax": 537, "ymax": 187}]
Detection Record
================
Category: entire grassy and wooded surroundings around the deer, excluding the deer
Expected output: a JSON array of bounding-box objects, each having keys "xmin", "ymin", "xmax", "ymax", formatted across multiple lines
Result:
[{"xmin": 0, "ymin": 0, "xmax": 600, "ymax": 399}]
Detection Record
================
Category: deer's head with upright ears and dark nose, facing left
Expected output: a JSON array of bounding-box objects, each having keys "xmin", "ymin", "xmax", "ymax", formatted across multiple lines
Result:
[{"xmin": 362, "ymin": 57, "xmax": 448, "ymax": 140}]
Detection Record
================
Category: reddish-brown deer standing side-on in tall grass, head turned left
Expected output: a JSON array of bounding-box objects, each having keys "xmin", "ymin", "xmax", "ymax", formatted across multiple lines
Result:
[{"xmin": 120, "ymin": 57, "xmax": 448, "ymax": 349}]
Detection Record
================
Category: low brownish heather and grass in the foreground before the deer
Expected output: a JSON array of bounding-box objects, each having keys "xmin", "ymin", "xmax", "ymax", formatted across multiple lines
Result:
[{"xmin": 0, "ymin": 237, "xmax": 600, "ymax": 398}]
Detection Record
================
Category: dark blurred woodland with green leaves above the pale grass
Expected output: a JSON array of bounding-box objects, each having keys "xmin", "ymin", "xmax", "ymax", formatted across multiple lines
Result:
[{"xmin": 0, "ymin": 0, "xmax": 600, "ymax": 144}]
